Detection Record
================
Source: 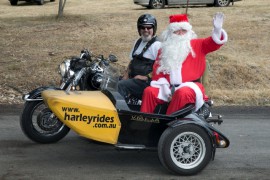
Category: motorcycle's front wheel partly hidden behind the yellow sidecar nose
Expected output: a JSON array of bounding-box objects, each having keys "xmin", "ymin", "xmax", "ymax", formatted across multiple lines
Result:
[{"xmin": 20, "ymin": 101, "xmax": 70, "ymax": 143}]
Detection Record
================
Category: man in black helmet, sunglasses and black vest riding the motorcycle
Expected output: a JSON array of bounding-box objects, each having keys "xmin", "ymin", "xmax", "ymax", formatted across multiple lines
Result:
[{"xmin": 118, "ymin": 14, "xmax": 161, "ymax": 100}]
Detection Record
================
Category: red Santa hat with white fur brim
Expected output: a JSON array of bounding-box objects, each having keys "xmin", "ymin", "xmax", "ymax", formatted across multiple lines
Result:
[{"xmin": 168, "ymin": 14, "xmax": 192, "ymax": 32}]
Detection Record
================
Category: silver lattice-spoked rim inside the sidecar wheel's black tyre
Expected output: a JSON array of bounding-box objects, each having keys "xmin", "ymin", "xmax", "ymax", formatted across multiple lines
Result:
[{"xmin": 170, "ymin": 132, "xmax": 206, "ymax": 169}]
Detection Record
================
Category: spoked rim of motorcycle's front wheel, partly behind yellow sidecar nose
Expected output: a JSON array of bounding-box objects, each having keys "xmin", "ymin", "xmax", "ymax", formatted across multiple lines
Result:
[{"xmin": 32, "ymin": 102, "xmax": 65, "ymax": 136}]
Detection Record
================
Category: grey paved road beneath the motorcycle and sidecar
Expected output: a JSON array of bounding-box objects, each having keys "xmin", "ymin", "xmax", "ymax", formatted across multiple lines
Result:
[{"xmin": 0, "ymin": 106, "xmax": 270, "ymax": 180}]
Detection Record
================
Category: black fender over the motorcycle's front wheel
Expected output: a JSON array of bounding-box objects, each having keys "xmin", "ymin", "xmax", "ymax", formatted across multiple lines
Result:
[{"xmin": 22, "ymin": 86, "xmax": 61, "ymax": 101}]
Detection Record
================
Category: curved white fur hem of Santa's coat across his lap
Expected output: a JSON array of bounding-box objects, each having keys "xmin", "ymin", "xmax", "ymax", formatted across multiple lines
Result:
[{"xmin": 175, "ymin": 82, "xmax": 204, "ymax": 111}]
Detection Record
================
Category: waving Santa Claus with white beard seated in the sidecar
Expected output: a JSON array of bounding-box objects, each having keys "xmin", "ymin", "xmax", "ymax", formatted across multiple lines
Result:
[{"xmin": 141, "ymin": 13, "xmax": 228, "ymax": 114}]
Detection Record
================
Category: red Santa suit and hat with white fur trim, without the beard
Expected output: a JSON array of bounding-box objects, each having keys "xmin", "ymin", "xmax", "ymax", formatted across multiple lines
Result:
[{"xmin": 141, "ymin": 15, "xmax": 227, "ymax": 114}]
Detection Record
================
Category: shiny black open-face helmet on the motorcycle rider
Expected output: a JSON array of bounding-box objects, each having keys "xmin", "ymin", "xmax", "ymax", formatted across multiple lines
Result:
[{"xmin": 137, "ymin": 14, "xmax": 157, "ymax": 35}]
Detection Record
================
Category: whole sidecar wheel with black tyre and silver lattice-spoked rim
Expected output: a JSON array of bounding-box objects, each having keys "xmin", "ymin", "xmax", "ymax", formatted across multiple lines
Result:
[{"xmin": 158, "ymin": 124, "xmax": 212, "ymax": 175}]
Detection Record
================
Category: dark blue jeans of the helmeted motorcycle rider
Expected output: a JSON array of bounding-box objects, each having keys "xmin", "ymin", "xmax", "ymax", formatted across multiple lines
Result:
[{"xmin": 118, "ymin": 79, "xmax": 150, "ymax": 99}]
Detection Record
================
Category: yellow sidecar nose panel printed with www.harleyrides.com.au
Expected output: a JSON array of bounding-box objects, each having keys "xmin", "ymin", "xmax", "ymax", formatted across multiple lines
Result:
[{"xmin": 42, "ymin": 90, "xmax": 121, "ymax": 144}]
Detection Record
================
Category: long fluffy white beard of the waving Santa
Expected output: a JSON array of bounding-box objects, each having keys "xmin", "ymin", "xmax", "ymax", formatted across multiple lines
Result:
[{"xmin": 157, "ymin": 32, "xmax": 195, "ymax": 74}]
